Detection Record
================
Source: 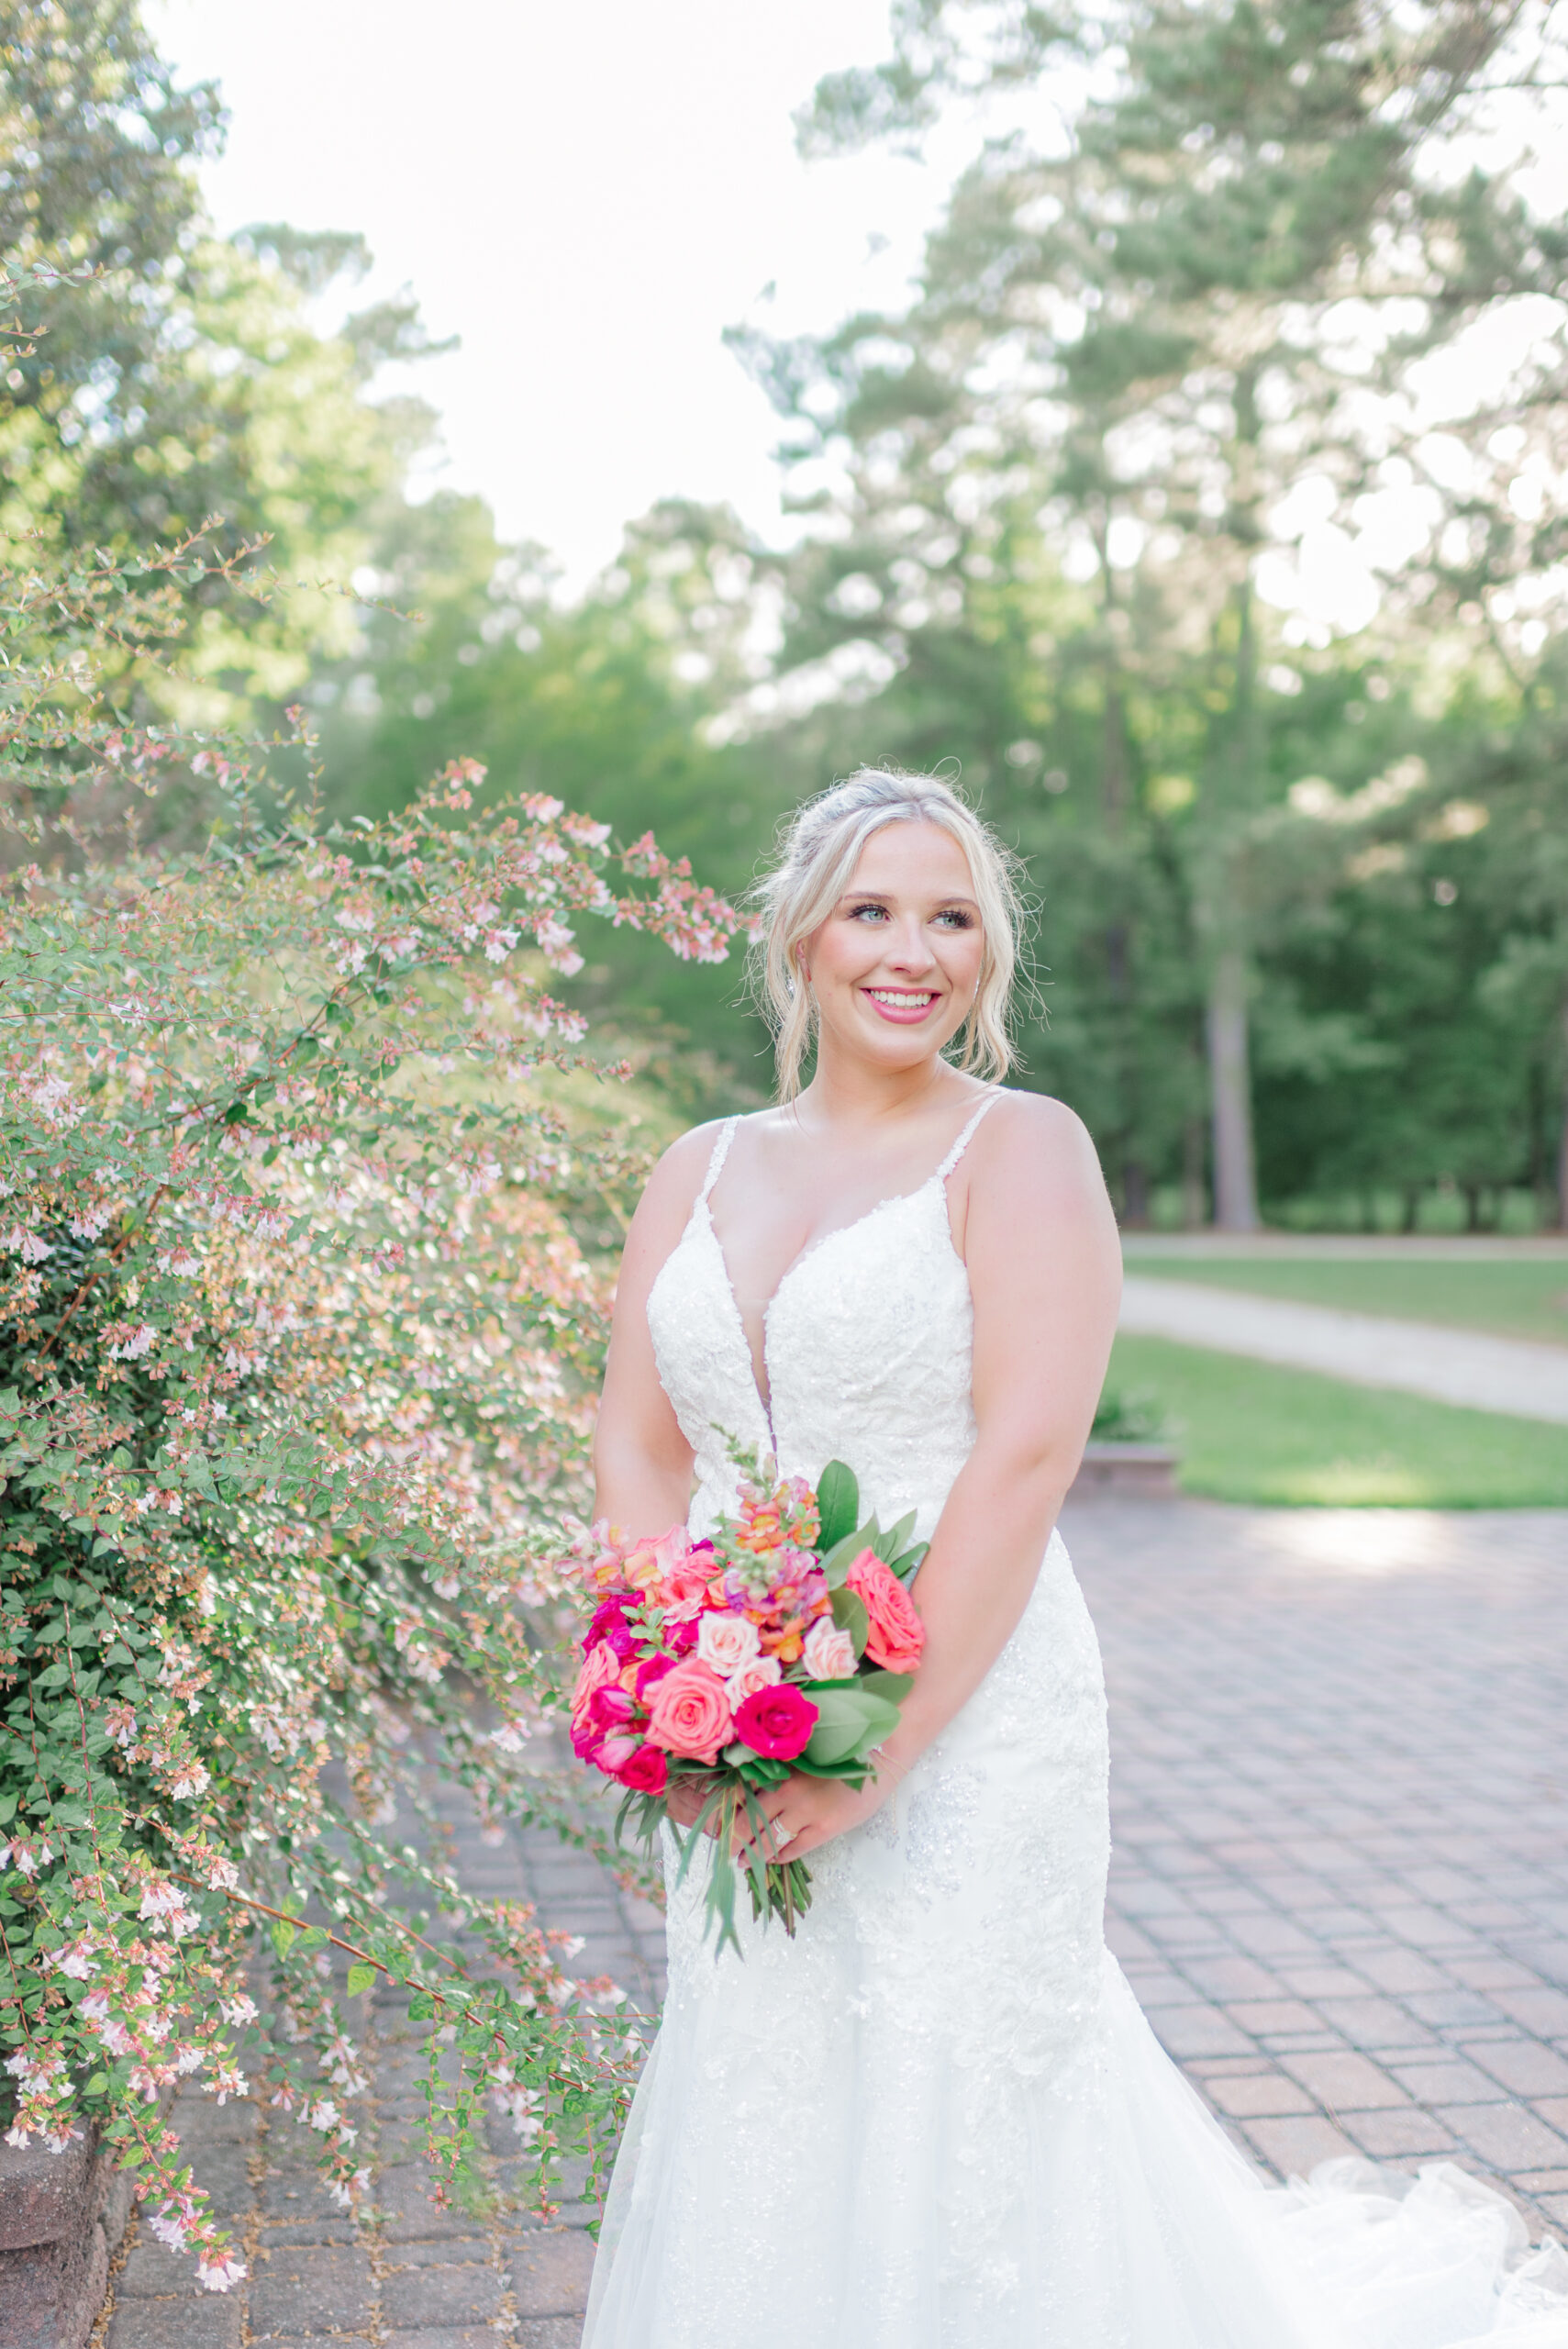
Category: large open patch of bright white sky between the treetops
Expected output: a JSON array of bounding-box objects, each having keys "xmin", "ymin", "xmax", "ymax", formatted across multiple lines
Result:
[{"xmin": 148, "ymin": 0, "xmax": 951, "ymax": 580}]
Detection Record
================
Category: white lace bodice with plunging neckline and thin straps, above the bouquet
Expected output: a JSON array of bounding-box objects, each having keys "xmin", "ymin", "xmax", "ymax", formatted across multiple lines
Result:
[{"xmin": 648, "ymin": 1092, "xmax": 997, "ymax": 1539}]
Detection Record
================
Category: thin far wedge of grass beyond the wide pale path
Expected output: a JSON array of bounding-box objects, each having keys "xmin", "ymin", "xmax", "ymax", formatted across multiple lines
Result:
[{"xmin": 1127, "ymin": 1252, "xmax": 1568, "ymax": 1346}]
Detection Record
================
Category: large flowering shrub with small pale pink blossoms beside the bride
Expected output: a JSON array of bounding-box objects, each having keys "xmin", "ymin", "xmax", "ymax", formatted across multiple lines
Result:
[{"xmin": 0, "ymin": 273, "xmax": 735, "ymax": 2288}]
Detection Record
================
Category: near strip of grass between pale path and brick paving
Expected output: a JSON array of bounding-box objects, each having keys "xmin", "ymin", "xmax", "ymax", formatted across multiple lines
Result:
[{"xmin": 1106, "ymin": 1343, "xmax": 1568, "ymax": 1508}]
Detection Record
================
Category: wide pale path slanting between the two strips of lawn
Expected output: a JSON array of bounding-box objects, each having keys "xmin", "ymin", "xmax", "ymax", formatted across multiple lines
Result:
[{"xmin": 1119, "ymin": 1274, "xmax": 1568, "ymax": 1426}]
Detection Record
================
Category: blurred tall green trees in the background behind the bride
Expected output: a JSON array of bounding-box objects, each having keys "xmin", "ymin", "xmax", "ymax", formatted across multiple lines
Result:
[{"xmin": 0, "ymin": 0, "xmax": 1568, "ymax": 1230}]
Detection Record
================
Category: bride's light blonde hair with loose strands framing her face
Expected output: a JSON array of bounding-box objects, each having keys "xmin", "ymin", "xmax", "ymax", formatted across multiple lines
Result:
[{"xmin": 753, "ymin": 766, "xmax": 1023, "ymax": 1102}]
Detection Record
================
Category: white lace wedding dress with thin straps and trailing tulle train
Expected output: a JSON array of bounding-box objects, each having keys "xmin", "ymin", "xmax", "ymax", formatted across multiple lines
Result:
[{"xmin": 584, "ymin": 1095, "xmax": 1568, "ymax": 2349}]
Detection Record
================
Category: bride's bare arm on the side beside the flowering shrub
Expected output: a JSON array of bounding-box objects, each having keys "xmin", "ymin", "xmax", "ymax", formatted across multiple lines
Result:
[{"xmin": 594, "ymin": 1125, "xmax": 714, "ymax": 1539}]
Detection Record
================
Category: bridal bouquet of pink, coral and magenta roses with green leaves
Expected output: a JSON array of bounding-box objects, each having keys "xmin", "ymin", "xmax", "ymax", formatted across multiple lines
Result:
[{"xmin": 573, "ymin": 1461, "xmax": 928, "ymax": 1950}]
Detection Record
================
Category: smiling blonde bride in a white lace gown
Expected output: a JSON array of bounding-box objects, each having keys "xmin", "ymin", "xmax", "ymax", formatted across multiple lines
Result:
[{"xmin": 584, "ymin": 771, "xmax": 1568, "ymax": 2349}]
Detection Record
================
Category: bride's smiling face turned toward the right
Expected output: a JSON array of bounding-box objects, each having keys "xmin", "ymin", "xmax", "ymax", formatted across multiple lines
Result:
[{"xmin": 800, "ymin": 822, "xmax": 986, "ymax": 1069}]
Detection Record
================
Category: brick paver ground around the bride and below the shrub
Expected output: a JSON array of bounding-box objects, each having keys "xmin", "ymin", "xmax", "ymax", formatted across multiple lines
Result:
[{"xmin": 106, "ymin": 1501, "xmax": 1568, "ymax": 2349}]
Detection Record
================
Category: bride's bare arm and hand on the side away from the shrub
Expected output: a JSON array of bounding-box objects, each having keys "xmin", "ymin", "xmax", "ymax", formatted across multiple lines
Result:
[{"xmin": 768, "ymin": 1095, "xmax": 1122, "ymax": 1861}]
